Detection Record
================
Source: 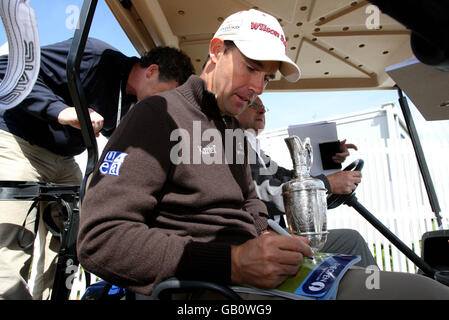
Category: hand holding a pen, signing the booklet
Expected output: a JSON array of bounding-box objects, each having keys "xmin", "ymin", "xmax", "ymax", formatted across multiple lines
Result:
[{"xmin": 231, "ymin": 232, "xmax": 313, "ymax": 289}]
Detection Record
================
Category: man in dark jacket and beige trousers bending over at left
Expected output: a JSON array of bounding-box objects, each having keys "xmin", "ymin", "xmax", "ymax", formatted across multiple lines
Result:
[{"xmin": 0, "ymin": 38, "xmax": 194, "ymax": 299}]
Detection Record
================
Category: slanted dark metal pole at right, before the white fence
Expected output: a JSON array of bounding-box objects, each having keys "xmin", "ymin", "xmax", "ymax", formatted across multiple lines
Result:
[{"xmin": 398, "ymin": 88, "xmax": 443, "ymax": 229}]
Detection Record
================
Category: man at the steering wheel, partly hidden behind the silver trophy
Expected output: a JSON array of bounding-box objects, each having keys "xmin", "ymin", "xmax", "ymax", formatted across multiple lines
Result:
[{"xmin": 236, "ymin": 97, "xmax": 376, "ymax": 267}]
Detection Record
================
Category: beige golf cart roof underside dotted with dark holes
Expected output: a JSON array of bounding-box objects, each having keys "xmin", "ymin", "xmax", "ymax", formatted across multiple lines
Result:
[{"xmin": 105, "ymin": 0, "xmax": 413, "ymax": 91}]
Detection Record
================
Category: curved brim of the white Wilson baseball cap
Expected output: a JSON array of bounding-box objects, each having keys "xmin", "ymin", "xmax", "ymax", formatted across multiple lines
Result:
[{"xmin": 234, "ymin": 40, "xmax": 301, "ymax": 82}]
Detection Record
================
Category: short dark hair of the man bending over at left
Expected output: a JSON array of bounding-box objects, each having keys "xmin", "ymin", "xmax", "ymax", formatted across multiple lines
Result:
[{"xmin": 140, "ymin": 47, "xmax": 195, "ymax": 85}]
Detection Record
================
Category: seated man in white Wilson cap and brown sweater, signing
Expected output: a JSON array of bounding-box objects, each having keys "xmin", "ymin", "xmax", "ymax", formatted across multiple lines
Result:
[{"xmin": 77, "ymin": 10, "xmax": 449, "ymax": 297}]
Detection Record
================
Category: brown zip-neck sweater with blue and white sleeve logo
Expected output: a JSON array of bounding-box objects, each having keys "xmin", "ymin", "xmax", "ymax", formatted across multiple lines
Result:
[{"xmin": 78, "ymin": 76, "xmax": 268, "ymax": 294}]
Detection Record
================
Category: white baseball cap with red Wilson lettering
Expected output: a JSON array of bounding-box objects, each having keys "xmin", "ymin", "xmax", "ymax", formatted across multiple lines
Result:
[{"xmin": 214, "ymin": 9, "xmax": 301, "ymax": 82}]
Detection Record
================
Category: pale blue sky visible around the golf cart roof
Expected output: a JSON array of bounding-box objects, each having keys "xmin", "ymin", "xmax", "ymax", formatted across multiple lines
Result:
[{"xmin": 0, "ymin": 0, "xmax": 449, "ymax": 139}]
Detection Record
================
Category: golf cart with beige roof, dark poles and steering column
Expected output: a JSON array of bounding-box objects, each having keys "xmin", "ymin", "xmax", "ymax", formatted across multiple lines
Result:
[{"xmin": 3, "ymin": 0, "xmax": 449, "ymax": 299}]
